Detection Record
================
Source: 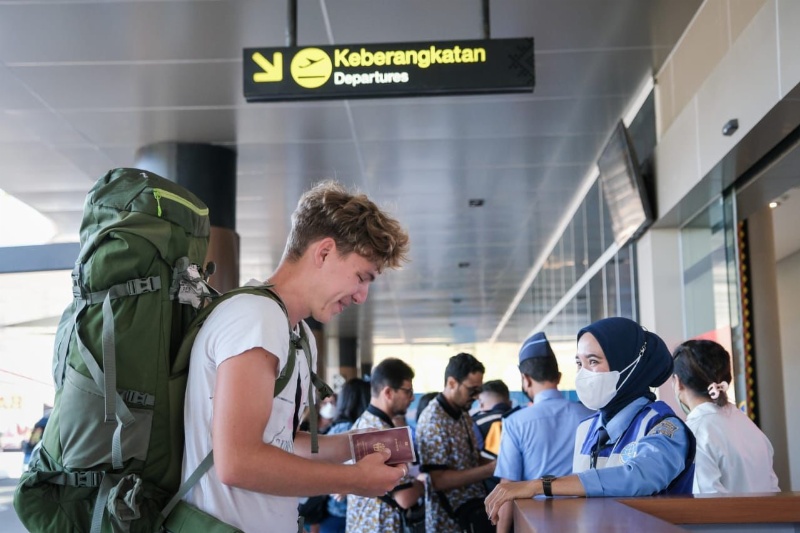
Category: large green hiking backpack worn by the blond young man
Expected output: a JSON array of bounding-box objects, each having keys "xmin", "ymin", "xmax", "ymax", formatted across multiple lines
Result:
[{"xmin": 14, "ymin": 168, "xmax": 332, "ymax": 533}]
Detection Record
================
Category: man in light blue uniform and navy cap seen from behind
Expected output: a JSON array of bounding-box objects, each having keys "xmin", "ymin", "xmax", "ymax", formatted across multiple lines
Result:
[{"xmin": 495, "ymin": 332, "xmax": 594, "ymax": 533}]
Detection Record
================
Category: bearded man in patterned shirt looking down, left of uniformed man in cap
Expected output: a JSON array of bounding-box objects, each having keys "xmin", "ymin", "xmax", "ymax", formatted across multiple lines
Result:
[{"xmin": 417, "ymin": 353, "xmax": 495, "ymax": 533}]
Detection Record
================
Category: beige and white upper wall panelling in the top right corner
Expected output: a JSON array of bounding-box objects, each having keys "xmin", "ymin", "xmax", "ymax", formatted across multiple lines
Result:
[{"xmin": 655, "ymin": 0, "xmax": 800, "ymax": 218}]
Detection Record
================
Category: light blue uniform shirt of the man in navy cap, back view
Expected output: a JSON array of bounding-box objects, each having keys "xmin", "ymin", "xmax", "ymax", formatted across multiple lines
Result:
[{"xmin": 494, "ymin": 389, "xmax": 594, "ymax": 481}]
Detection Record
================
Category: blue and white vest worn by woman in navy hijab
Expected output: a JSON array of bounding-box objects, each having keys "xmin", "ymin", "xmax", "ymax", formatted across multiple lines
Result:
[{"xmin": 572, "ymin": 401, "xmax": 695, "ymax": 494}]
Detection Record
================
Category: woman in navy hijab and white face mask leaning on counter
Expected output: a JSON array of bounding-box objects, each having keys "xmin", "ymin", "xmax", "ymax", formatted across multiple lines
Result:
[{"xmin": 486, "ymin": 317, "xmax": 695, "ymax": 520}]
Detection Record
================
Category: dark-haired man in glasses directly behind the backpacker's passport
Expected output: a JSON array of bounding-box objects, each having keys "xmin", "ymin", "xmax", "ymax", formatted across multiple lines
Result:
[{"xmin": 347, "ymin": 358, "xmax": 424, "ymax": 533}]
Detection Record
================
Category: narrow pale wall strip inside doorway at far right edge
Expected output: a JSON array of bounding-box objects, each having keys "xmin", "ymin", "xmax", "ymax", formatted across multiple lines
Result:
[{"xmin": 776, "ymin": 251, "xmax": 800, "ymax": 491}]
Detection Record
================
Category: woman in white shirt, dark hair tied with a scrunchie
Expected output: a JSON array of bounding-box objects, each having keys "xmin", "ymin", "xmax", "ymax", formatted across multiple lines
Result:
[{"xmin": 673, "ymin": 340, "xmax": 780, "ymax": 494}]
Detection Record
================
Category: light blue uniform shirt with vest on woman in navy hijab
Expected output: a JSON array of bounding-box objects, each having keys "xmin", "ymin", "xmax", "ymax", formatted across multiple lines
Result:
[{"xmin": 574, "ymin": 398, "xmax": 694, "ymax": 496}]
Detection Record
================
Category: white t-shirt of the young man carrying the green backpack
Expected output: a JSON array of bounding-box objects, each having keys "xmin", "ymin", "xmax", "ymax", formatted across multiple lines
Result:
[{"xmin": 182, "ymin": 294, "xmax": 317, "ymax": 533}]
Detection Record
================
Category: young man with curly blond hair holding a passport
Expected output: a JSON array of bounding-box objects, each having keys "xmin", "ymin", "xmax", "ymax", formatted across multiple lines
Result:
[{"xmin": 183, "ymin": 181, "xmax": 408, "ymax": 533}]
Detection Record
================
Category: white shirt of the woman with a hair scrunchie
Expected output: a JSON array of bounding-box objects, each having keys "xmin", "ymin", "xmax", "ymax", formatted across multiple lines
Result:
[{"xmin": 686, "ymin": 402, "xmax": 780, "ymax": 494}]
